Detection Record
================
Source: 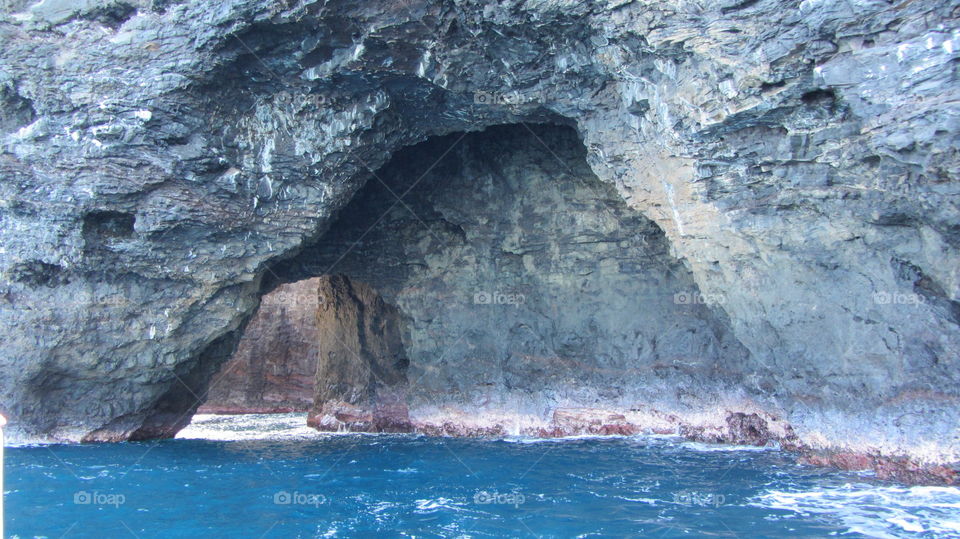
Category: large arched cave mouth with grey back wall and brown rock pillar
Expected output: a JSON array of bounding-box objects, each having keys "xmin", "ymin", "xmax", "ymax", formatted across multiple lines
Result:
[{"xmin": 191, "ymin": 124, "xmax": 746, "ymax": 434}]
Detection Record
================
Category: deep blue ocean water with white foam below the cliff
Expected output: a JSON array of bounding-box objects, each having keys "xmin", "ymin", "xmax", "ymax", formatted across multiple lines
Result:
[{"xmin": 5, "ymin": 415, "xmax": 960, "ymax": 538}]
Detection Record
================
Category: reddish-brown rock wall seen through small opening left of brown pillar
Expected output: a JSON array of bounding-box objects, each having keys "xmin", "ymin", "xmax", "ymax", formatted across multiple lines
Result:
[{"xmin": 198, "ymin": 277, "xmax": 324, "ymax": 414}]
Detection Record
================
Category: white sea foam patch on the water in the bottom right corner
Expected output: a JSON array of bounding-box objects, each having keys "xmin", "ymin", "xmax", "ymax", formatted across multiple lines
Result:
[{"xmin": 751, "ymin": 484, "xmax": 960, "ymax": 538}]
